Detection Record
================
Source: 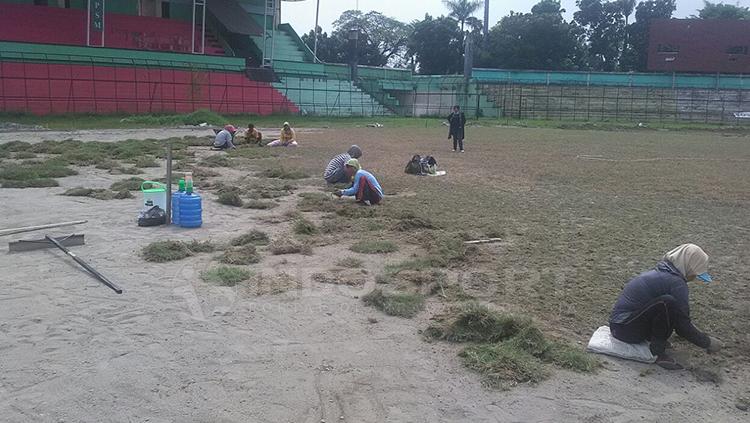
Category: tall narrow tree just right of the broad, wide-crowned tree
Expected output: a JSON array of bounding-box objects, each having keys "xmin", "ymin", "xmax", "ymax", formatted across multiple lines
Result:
[{"xmin": 573, "ymin": 0, "xmax": 625, "ymax": 72}]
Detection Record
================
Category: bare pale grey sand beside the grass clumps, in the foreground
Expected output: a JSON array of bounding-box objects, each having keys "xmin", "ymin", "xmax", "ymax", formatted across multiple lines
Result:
[{"xmin": 0, "ymin": 127, "xmax": 748, "ymax": 423}]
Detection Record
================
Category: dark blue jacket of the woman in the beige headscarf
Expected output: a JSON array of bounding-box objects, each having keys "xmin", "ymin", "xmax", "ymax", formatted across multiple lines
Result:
[{"xmin": 609, "ymin": 261, "xmax": 690, "ymax": 323}]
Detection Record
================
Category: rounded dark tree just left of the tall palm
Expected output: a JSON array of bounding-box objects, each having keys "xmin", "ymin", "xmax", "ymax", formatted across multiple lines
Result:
[{"xmin": 408, "ymin": 15, "xmax": 463, "ymax": 75}]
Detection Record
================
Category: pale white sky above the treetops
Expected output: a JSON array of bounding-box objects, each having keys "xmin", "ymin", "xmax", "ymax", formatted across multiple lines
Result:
[{"xmin": 281, "ymin": 0, "xmax": 712, "ymax": 35}]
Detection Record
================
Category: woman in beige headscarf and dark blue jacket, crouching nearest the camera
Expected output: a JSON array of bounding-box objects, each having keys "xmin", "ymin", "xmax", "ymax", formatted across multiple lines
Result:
[{"xmin": 609, "ymin": 244, "xmax": 723, "ymax": 370}]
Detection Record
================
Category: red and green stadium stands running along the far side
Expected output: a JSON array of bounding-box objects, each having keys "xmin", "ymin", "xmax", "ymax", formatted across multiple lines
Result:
[{"xmin": 0, "ymin": 0, "xmax": 750, "ymax": 122}]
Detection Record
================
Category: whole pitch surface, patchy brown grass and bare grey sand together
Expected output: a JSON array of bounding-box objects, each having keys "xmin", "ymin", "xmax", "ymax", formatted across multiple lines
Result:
[{"xmin": 0, "ymin": 121, "xmax": 750, "ymax": 422}]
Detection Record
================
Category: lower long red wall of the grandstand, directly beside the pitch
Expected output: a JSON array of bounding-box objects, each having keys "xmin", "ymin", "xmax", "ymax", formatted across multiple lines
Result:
[{"xmin": 0, "ymin": 62, "xmax": 299, "ymax": 115}]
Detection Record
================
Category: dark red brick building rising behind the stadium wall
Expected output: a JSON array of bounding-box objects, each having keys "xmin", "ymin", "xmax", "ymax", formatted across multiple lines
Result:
[{"xmin": 648, "ymin": 19, "xmax": 750, "ymax": 74}]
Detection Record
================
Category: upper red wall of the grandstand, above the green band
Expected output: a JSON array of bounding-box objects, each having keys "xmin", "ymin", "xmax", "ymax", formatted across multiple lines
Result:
[{"xmin": 0, "ymin": 3, "xmax": 223, "ymax": 55}]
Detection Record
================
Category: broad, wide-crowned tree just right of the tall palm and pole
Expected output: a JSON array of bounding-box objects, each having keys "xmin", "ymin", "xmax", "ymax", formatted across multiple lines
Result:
[{"xmin": 479, "ymin": 0, "xmax": 583, "ymax": 70}]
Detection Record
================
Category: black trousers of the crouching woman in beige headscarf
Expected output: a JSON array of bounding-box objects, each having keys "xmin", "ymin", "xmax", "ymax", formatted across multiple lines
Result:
[{"xmin": 609, "ymin": 295, "xmax": 711, "ymax": 355}]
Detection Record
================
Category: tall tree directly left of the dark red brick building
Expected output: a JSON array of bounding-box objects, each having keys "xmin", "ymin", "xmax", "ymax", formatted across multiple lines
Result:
[{"xmin": 622, "ymin": 0, "xmax": 677, "ymax": 72}]
